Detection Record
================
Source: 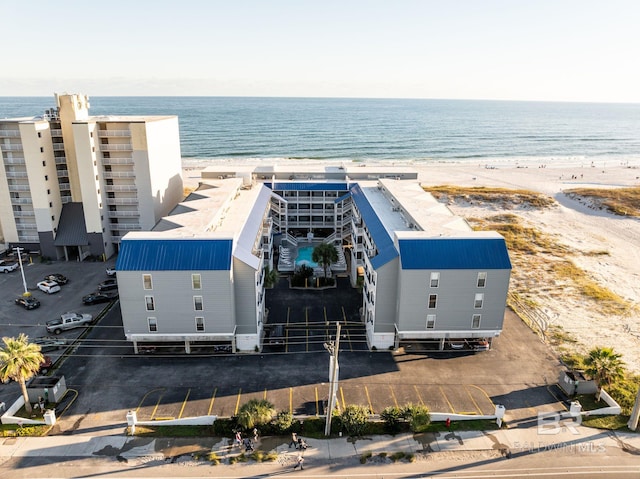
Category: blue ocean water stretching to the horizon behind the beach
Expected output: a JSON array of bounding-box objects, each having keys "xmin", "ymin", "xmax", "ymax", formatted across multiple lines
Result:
[{"xmin": 0, "ymin": 96, "xmax": 640, "ymax": 164}]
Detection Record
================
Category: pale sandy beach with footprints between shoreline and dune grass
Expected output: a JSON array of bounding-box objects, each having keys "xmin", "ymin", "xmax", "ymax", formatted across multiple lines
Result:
[{"xmin": 184, "ymin": 159, "xmax": 640, "ymax": 373}]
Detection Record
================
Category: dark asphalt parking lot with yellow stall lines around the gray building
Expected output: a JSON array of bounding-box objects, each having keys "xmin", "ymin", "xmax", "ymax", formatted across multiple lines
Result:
[{"xmin": 0, "ymin": 262, "xmax": 564, "ymax": 434}]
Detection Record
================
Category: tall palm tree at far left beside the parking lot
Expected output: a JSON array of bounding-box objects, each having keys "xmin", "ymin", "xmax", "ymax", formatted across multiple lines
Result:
[{"xmin": 0, "ymin": 334, "xmax": 44, "ymax": 413}]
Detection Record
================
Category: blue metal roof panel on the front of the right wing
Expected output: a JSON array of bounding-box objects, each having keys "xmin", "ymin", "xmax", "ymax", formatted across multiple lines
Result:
[{"xmin": 398, "ymin": 238, "xmax": 511, "ymax": 270}]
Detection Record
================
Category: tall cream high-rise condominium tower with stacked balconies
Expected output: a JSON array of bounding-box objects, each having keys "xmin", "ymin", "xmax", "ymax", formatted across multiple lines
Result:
[{"xmin": 0, "ymin": 94, "xmax": 183, "ymax": 260}]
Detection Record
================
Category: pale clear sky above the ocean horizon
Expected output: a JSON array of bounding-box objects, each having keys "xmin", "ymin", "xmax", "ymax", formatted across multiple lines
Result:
[{"xmin": 0, "ymin": 0, "xmax": 640, "ymax": 102}]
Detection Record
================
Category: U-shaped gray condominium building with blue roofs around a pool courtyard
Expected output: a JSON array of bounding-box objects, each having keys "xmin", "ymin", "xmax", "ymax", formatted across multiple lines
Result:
[{"xmin": 117, "ymin": 167, "xmax": 511, "ymax": 351}]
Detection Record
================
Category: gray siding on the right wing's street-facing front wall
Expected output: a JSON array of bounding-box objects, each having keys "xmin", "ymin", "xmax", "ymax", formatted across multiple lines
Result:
[{"xmin": 398, "ymin": 270, "xmax": 510, "ymax": 331}]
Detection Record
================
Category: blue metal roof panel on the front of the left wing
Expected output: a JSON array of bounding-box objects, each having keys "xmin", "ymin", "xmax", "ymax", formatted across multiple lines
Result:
[{"xmin": 116, "ymin": 236, "xmax": 233, "ymax": 271}]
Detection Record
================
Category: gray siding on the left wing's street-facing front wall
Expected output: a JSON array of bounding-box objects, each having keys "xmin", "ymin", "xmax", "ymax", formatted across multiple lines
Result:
[{"xmin": 118, "ymin": 271, "xmax": 235, "ymax": 335}]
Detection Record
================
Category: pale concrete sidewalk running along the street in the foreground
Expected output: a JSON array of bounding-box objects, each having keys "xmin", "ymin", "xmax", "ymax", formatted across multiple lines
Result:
[{"xmin": 0, "ymin": 427, "xmax": 640, "ymax": 472}]
